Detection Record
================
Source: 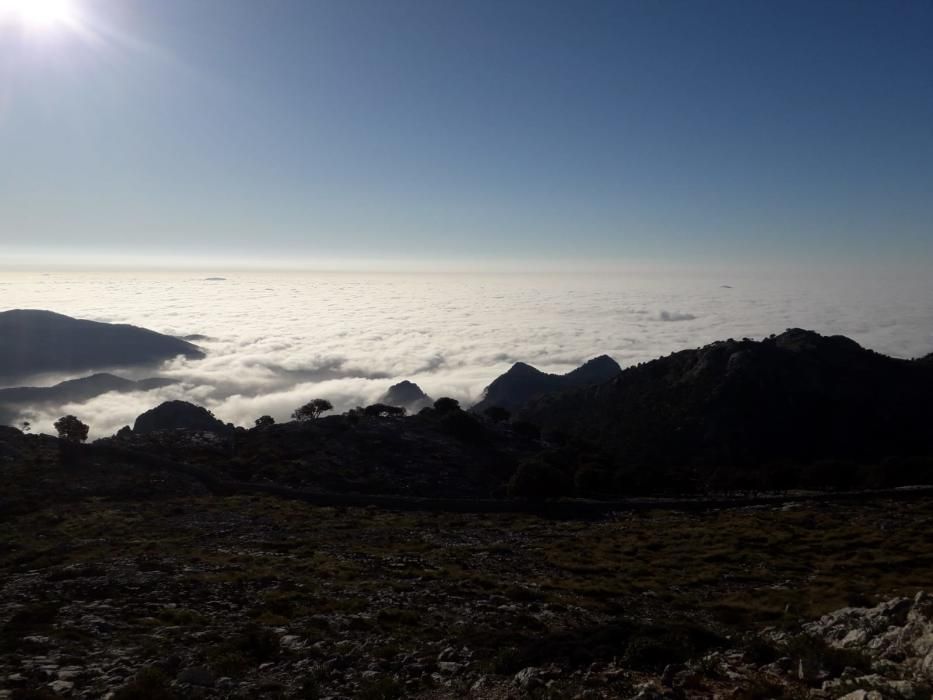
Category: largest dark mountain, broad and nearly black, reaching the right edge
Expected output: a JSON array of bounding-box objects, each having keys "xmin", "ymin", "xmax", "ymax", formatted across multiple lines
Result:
[{"xmin": 521, "ymin": 329, "xmax": 933, "ymax": 476}]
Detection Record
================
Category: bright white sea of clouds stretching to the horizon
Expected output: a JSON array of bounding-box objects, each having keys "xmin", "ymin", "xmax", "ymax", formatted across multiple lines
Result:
[{"xmin": 0, "ymin": 268, "xmax": 933, "ymax": 437}]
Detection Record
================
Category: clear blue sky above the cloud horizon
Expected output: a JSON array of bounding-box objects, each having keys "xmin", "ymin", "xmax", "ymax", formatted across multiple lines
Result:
[{"xmin": 0, "ymin": 0, "xmax": 933, "ymax": 265}]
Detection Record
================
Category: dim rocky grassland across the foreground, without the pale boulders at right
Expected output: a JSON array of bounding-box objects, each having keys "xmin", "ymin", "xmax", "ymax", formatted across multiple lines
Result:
[{"xmin": 0, "ymin": 484, "xmax": 933, "ymax": 699}]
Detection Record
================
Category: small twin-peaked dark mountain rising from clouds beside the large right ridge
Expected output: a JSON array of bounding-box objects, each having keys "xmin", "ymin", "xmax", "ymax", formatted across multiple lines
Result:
[{"xmin": 472, "ymin": 355, "xmax": 622, "ymax": 412}]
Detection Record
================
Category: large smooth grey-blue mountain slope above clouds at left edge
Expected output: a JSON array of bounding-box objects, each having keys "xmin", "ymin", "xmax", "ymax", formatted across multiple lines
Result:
[{"xmin": 0, "ymin": 309, "xmax": 204, "ymax": 380}]
